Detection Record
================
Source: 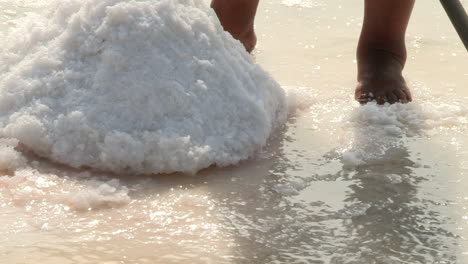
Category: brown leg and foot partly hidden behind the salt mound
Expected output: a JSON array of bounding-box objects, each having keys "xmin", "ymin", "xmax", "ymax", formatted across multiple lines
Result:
[{"xmin": 211, "ymin": 0, "xmax": 258, "ymax": 52}]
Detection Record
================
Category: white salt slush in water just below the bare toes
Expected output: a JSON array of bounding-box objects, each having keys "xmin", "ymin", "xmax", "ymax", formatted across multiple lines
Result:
[{"xmin": 342, "ymin": 98, "xmax": 468, "ymax": 167}]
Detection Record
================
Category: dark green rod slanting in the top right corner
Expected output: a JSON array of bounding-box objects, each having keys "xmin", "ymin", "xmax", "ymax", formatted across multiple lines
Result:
[{"xmin": 440, "ymin": 0, "xmax": 468, "ymax": 51}]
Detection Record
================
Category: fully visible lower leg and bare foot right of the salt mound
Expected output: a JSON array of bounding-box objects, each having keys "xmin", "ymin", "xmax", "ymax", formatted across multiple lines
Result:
[{"xmin": 356, "ymin": 0, "xmax": 414, "ymax": 103}]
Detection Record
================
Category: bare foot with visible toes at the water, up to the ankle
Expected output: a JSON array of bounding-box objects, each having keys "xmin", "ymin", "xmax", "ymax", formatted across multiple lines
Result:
[{"xmin": 355, "ymin": 50, "xmax": 412, "ymax": 104}]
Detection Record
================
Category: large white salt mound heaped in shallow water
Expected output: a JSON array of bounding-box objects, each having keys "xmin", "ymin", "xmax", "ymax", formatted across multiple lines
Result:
[{"xmin": 0, "ymin": 0, "xmax": 287, "ymax": 173}]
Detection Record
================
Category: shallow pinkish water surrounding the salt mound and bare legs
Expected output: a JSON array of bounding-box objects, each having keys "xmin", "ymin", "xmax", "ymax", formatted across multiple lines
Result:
[{"xmin": 0, "ymin": 0, "xmax": 468, "ymax": 263}]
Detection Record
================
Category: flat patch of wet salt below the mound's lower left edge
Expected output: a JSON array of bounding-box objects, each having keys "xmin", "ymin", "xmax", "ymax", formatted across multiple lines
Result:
[{"xmin": 0, "ymin": 168, "xmax": 130, "ymax": 211}]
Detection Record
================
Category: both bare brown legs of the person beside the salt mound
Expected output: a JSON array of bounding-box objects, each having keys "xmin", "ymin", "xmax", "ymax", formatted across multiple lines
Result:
[{"xmin": 211, "ymin": 0, "xmax": 415, "ymax": 104}]
